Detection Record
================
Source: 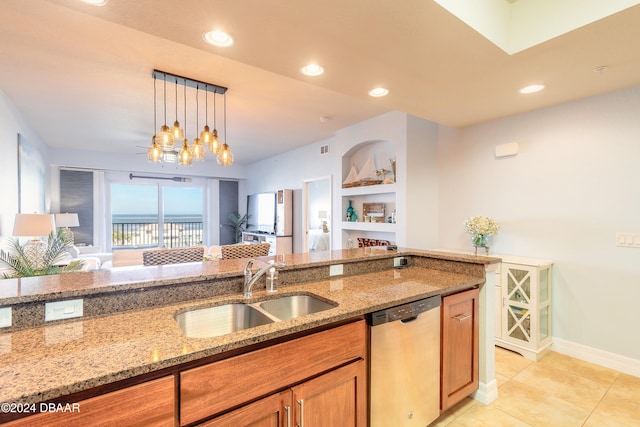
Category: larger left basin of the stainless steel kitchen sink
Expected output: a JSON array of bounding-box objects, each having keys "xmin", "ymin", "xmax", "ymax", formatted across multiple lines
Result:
[{"xmin": 176, "ymin": 304, "xmax": 273, "ymax": 338}]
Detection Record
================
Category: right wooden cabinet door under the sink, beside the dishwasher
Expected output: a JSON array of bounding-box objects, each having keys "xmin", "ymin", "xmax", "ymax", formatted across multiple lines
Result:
[{"xmin": 292, "ymin": 360, "xmax": 367, "ymax": 427}]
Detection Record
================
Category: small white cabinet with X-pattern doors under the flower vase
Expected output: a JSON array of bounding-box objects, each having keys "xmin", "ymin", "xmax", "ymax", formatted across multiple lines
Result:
[{"xmin": 496, "ymin": 257, "xmax": 553, "ymax": 360}]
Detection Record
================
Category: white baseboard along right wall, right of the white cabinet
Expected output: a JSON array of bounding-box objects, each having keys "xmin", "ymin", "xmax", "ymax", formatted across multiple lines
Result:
[{"xmin": 551, "ymin": 337, "xmax": 640, "ymax": 377}]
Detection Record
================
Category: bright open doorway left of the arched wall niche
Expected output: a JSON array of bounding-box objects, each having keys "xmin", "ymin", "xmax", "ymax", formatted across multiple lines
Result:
[{"xmin": 302, "ymin": 176, "xmax": 332, "ymax": 252}]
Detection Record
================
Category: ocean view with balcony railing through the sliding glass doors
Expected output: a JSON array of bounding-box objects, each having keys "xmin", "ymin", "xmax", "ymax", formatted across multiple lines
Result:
[{"xmin": 111, "ymin": 184, "xmax": 203, "ymax": 249}]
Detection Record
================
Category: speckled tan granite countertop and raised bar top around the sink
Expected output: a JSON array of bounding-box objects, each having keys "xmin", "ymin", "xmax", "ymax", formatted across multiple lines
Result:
[{"xmin": 0, "ymin": 250, "xmax": 499, "ymax": 410}]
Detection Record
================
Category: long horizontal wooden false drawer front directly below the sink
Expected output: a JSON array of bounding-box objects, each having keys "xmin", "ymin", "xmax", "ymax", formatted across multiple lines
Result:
[{"xmin": 180, "ymin": 320, "xmax": 366, "ymax": 425}]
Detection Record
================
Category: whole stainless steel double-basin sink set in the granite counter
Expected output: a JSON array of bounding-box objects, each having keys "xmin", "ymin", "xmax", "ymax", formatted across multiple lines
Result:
[{"xmin": 176, "ymin": 295, "xmax": 335, "ymax": 338}]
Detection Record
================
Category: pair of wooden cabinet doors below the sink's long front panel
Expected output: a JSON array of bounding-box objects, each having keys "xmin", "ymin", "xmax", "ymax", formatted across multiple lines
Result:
[{"xmin": 200, "ymin": 360, "xmax": 367, "ymax": 427}]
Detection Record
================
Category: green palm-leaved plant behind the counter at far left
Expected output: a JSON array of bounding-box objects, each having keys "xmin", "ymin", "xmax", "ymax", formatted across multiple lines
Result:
[{"xmin": 0, "ymin": 228, "xmax": 82, "ymax": 279}]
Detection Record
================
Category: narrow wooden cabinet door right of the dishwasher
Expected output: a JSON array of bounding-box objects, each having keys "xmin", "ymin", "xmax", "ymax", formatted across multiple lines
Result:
[{"xmin": 440, "ymin": 289, "xmax": 480, "ymax": 411}]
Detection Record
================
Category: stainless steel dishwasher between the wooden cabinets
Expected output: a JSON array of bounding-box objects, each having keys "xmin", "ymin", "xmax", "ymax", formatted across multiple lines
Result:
[{"xmin": 368, "ymin": 295, "xmax": 441, "ymax": 427}]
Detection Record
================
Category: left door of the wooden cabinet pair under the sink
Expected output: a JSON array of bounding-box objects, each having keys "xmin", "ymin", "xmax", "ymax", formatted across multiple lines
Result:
[{"xmin": 199, "ymin": 390, "xmax": 292, "ymax": 427}]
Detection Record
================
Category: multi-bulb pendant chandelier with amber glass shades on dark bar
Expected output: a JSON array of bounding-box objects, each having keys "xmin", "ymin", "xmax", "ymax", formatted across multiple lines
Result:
[{"xmin": 147, "ymin": 70, "xmax": 233, "ymax": 166}]
